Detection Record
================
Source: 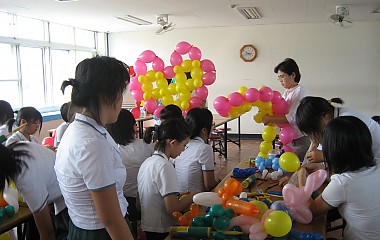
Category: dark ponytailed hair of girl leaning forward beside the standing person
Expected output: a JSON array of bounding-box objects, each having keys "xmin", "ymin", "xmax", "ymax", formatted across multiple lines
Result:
[{"xmin": 296, "ymin": 96, "xmax": 344, "ymax": 142}]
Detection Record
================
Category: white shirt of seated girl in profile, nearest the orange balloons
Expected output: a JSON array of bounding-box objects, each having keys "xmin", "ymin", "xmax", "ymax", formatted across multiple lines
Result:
[{"xmin": 137, "ymin": 151, "xmax": 179, "ymax": 233}]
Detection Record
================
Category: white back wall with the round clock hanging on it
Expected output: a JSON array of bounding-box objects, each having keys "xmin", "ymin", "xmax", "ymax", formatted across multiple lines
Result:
[{"xmin": 109, "ymin": 22, "xmax": 380, "ymax": 133}]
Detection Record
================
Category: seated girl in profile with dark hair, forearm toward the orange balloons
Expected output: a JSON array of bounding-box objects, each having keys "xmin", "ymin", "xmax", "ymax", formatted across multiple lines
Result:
[{"xmin": 137, "ymin": 118, "xmax": 196, "ymax": 239}]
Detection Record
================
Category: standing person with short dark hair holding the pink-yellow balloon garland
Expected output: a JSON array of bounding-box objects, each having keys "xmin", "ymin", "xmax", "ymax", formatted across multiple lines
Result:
[{"xmin": 263, "ymin": 58, "xmax": 310, "ymax": 160}]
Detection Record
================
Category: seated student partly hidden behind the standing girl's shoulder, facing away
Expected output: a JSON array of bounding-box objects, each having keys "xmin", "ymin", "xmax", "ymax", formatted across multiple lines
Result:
[{"xmin": 107, "ymin": 109, "xmax": 154, "ymax": 235}]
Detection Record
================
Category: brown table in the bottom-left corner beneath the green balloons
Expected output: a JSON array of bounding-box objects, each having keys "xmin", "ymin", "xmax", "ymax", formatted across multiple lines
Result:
[{"xmin": 0, "ymin": 205, "xmax": 33, "ymax": 240}]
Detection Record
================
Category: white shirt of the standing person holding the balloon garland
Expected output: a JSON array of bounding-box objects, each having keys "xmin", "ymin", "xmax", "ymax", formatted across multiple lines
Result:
[{"xmin": 282, "ymin": 85, "xmax": 307, "ymax": 139}]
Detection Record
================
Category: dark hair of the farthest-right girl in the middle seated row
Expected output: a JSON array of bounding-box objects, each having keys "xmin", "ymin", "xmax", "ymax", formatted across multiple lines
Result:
[{"xmin": 186, "ymin": 108, "xmax": 213, "ymax": 138}]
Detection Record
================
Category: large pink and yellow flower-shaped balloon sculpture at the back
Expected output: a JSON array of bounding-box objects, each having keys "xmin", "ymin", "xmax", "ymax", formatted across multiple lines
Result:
[{"xmin": 129, "ymin": 42, "xmax": 216, "ymax": 117}]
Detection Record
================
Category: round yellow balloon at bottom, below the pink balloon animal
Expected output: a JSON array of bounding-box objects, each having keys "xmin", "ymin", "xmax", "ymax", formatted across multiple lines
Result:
[{"xmin": 264, "ymin": 211, "xmax": 292, "ymax": 237}]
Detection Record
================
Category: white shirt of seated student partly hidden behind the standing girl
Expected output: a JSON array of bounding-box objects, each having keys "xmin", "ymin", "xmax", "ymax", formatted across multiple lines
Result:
[{"xmin": 119, "ymin": 139, "xmax": 154, "ymax": 197}]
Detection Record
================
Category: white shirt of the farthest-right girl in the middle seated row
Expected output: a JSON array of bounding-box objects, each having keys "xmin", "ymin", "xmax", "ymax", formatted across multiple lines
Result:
[{"xmin": 175, "ymin": 137, "xmax": 215, "ymax": 192}]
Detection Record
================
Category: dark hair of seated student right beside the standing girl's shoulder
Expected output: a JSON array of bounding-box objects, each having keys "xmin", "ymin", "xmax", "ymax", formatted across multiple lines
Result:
[{"xmin": 107, "ymin": 109, "xmax": 136, "ymax": 146}]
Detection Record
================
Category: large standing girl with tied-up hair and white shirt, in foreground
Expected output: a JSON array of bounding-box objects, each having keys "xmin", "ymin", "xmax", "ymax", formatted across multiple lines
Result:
[{"xmin": 55, "ymin": 56, "xmax": 133, "ymax": 240}]
